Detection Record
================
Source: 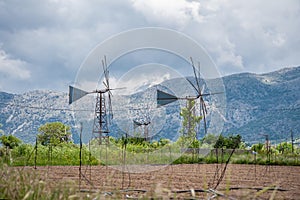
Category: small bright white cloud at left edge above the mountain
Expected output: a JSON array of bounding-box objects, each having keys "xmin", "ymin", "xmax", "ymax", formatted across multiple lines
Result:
[{"xmin": 0, "ymin": 49, "xmax": 30, "ymax": 80}]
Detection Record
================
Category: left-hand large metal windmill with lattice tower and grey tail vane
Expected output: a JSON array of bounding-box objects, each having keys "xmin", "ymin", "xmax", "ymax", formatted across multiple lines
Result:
[{"xmin": 69, "ymin": 56, "xmax": 113, "ymax": 144}]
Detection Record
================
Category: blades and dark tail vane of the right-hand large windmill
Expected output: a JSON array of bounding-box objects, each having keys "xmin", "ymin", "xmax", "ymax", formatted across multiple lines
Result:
[{"xmin": 157, "ymin": 57, "xmax": 221, "ymax": 134}]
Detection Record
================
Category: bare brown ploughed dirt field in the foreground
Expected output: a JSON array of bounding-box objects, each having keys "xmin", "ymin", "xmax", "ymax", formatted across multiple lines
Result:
[{"xmin": 22, "ymin": 164, "xmax": 300, "ymax": 199}]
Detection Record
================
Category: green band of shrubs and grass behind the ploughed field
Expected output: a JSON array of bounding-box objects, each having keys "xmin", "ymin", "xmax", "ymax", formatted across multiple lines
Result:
[{"xmin": 0, "ymin": 121, "xmax": 300, "ymax": 166}]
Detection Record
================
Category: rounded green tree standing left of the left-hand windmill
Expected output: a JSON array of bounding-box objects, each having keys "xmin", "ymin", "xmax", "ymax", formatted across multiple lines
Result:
[{"xmin": 37, "ymin": 122, "xmax": 71, "ymax": 145}]
